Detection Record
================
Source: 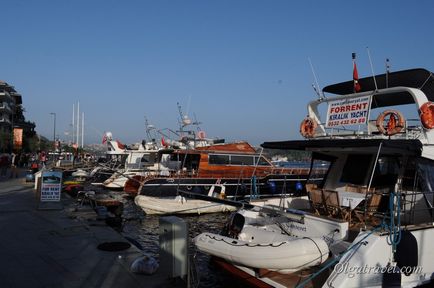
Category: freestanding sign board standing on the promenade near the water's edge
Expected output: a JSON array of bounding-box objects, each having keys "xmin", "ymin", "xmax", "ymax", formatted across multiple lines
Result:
[{"xmin": 38, "ymin": 171, "xmax": 63, "ymax": 210}]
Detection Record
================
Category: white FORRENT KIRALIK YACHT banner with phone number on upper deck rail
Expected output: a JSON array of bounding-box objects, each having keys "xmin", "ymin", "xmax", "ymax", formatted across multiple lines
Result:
[{"xmin": 326, "ymin": 96, "xmax": 371, "ymax": 128}]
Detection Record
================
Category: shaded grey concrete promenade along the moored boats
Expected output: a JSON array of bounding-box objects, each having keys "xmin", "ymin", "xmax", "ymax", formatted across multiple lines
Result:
[{"xmin": 0, "ymin": 171, "xmax": 181, "ymax": 288}]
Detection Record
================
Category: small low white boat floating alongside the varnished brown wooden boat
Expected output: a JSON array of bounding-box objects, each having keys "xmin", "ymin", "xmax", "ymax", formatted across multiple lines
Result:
[{"xmin": 134, "ymin": 195, "xmax": 237, "ymax": 214}]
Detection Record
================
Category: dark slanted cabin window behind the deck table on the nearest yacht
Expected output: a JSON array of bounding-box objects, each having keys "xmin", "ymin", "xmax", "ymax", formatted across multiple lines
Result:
[{"xmin": 340, "ymin": 154, "xmax": 372, "ymax": 185}]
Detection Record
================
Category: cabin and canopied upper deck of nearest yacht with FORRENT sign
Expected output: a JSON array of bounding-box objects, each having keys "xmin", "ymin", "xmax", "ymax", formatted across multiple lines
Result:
[{"xmin": 262, "ymin": 69, "xmax": 434, "ymax": 225}]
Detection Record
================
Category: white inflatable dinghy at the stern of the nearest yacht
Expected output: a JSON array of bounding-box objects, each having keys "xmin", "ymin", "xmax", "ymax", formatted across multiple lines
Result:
[{"xmin": 194, "ymin": 206, "xmax": 348, "ymax": 274}]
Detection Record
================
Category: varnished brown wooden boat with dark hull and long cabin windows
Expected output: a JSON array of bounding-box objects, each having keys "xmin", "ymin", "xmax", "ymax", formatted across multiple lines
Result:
[{"xmin": 124, "ymin": 142, "xmax": 309, "ymax": 199}]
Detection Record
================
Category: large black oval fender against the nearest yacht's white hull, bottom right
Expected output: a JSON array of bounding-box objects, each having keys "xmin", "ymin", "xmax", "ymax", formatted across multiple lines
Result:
[{"xmin": 395, "ymin": 230, "xmax": 419, "ymax": 276}]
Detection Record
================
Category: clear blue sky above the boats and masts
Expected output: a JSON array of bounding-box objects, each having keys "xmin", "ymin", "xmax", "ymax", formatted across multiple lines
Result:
[{"xmin": 0, "ymin": 0, "xmax": 434, "ymax": 145}]
